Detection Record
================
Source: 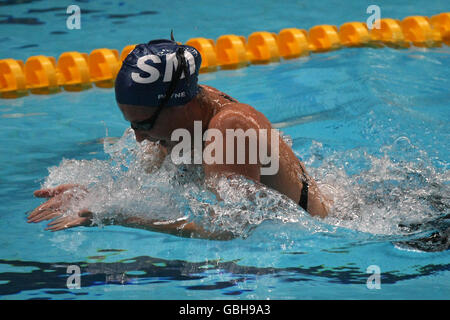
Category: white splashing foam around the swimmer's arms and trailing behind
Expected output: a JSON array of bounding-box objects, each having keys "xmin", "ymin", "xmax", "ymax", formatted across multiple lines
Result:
[{"xmin": 43, "ymin": 129, "xmax": 450, "ymax": 246}]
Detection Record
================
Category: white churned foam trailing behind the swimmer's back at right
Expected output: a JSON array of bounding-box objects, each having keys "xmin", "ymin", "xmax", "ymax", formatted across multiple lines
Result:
[{"xmin": 307, "ymin": 137, "xmax": 450, "ymax": 239}]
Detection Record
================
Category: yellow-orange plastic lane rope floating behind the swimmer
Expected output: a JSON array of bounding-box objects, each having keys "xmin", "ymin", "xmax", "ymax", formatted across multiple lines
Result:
[{"xmin": 0, "ymin": 12, "xmax": 450, "ymax": 98}]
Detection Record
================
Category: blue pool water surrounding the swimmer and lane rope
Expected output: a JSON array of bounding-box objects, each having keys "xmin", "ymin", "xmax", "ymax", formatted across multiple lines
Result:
[{"xmin": 0, "ymin": 0, "xmax": 450, "ymax": 299}]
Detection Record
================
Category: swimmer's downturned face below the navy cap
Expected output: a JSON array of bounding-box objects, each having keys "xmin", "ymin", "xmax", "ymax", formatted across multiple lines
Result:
[{"xmin": 118, "ymin": 103, "xmax": 189, "ymax": 148}]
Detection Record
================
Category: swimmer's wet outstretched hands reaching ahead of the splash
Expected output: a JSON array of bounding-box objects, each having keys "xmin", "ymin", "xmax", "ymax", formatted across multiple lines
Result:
[{"xmin": 28, "ymin": 184, "xmax": 92, "ymax": 231}]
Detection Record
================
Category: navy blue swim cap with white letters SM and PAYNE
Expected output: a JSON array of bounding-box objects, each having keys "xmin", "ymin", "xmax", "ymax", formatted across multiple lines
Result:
[{"xmin": 115, "ymin": 40, "xmax": 202, "ymax": 107}]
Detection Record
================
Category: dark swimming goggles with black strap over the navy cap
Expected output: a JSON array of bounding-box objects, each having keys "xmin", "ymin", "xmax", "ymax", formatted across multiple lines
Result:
[{"xmin": 131, "ymin": 47, "xmax": 189, "ymax": 131}]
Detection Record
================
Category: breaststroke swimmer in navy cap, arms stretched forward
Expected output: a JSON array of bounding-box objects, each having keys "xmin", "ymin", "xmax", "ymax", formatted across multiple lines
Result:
[{"xmin": 28, "ymin": 40, "xmax": 329, "ymax": 239}]
